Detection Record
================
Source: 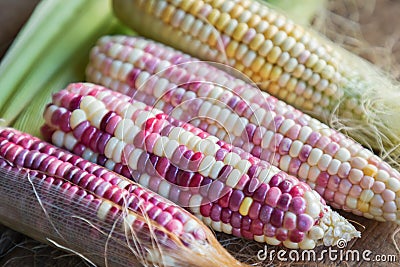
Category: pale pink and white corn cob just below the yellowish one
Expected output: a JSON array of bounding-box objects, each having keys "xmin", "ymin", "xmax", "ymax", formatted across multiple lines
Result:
[{"xmin": 86, "ymin": 36, "xmax": 400, "ymax": 223}]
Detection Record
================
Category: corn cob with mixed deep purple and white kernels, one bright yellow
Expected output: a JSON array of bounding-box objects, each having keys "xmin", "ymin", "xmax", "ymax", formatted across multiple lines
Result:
[{"xmin": 42, "ymin": 83, "xmax": 359, "ymax": 249}]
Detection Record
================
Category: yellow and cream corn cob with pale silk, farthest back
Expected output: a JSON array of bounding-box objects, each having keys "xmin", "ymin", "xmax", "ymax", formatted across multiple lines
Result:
[{"xmin": 113, "ymin": 0, "xmax": 400, "ymax": 164}]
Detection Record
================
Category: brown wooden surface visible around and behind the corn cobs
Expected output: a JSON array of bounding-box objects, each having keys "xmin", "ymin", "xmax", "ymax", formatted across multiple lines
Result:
[{"xmin": 0, "ymin": 0, "xmax": 400, "ymax": 266}]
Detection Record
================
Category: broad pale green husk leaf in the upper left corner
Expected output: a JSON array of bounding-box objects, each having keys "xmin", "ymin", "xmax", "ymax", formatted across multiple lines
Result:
[{"xmin": 0, "ymin": 0, "xmax": 117, "ymax": 126}]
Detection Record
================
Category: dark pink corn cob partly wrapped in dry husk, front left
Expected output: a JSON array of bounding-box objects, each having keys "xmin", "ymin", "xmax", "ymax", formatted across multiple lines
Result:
[{"xmin": 0, "ymin": 129, "xmax": 242, "ymax": 266}]
